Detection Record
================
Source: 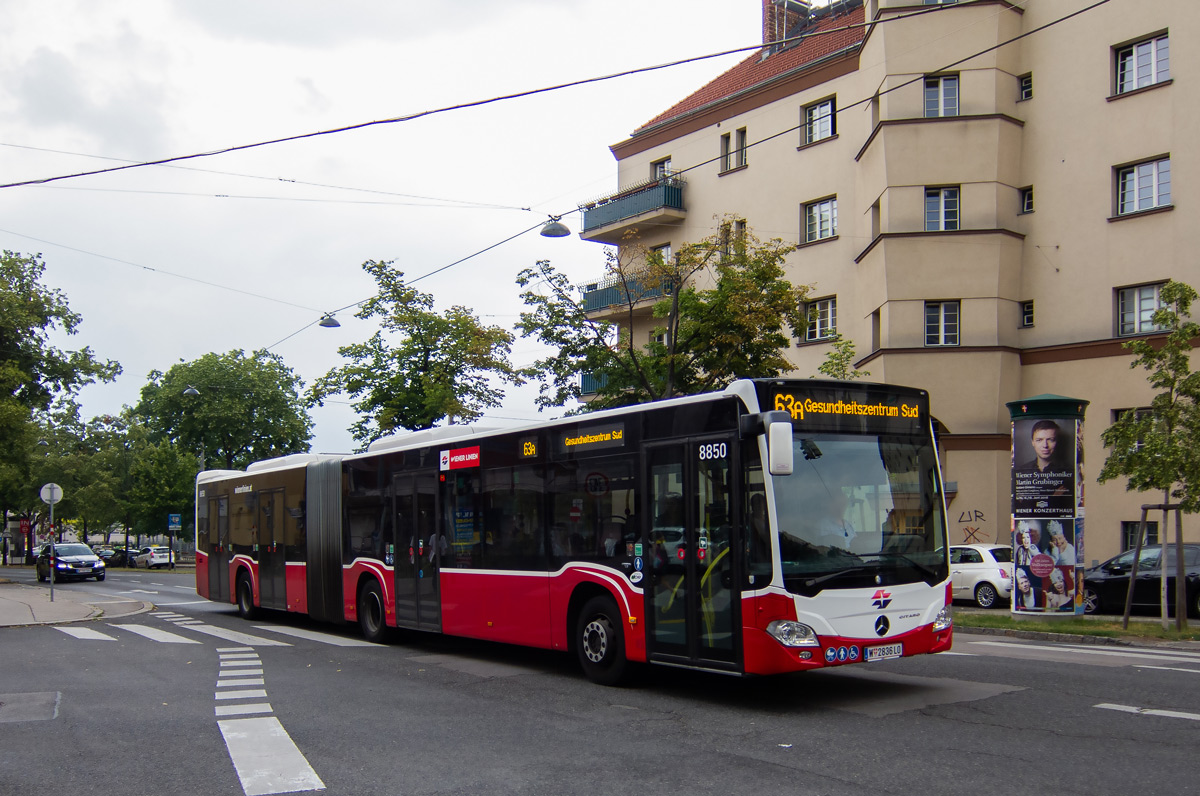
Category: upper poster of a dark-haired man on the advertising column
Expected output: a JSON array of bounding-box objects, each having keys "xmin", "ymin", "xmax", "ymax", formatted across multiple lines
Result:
[{"xmin": 1013, "ymin": 418, "xmax": 1080, "ymax": 519}]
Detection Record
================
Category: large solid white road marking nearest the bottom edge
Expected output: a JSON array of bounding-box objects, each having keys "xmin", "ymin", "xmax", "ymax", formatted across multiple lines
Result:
[{"xmin": 217, "ymin": 717, "xmax": 325, "ymax": 796}]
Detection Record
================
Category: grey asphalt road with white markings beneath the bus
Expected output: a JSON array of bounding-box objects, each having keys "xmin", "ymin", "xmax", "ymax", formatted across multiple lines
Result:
[{"xmin": 0, "ymin": 570, "xmax": 1200, "ymax": 796}]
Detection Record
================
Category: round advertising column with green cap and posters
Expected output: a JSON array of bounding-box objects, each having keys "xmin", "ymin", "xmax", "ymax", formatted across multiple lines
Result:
[{"xmin": 1007, "ymin": 395, "xmax": 1088, "ymax": 616}]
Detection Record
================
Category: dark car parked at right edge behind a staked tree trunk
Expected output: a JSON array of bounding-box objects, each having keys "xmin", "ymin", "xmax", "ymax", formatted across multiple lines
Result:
[{"xmin": 1084, "ymin": 544, "xmax": 1200, "ymax": 616}]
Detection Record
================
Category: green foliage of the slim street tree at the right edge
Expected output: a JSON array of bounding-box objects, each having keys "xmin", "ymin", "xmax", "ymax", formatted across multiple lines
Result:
[{"xmin": 1099, "ymin": 282, "xmax": 1200, "ymax": 513}]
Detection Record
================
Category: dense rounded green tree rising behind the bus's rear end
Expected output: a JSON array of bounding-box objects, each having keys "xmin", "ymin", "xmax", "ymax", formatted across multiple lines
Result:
[{"xmin": 134, "ymin": 351, "xmax": 312, "ymax": 469}]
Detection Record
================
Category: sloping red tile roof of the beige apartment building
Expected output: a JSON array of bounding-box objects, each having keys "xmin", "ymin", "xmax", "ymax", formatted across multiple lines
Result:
[{"xmin": 634, "ymin": 5, "xmax": 865, "ymax": 136}]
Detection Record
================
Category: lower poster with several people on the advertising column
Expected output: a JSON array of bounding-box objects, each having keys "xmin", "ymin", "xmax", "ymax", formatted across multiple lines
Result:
[{"xmin": 1012, "ymin": 517, "xmax": 1084, "ymax": 614}]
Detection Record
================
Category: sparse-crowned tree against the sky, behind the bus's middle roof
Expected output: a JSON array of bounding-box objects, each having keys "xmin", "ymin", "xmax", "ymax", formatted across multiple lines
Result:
[{"xmin": 308, "ymin": 261, "xmax": 521, "ymax": 445}]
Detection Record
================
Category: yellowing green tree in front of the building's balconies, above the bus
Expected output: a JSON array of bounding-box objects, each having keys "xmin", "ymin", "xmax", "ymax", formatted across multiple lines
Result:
[{"xmin": 517, "ymin": 225, "xmax": 808, "ymax": 409}]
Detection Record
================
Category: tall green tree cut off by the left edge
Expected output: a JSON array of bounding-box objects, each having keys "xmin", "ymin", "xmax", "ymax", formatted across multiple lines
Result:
[{"xmin": 0, "ymin": 251, "xmax": 121, "ymax": 535}]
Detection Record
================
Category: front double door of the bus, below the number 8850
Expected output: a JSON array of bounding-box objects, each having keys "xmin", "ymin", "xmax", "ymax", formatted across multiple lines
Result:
[{"xmin": 642, "ymin": 436, "xmax": 740, "ymax": 670}]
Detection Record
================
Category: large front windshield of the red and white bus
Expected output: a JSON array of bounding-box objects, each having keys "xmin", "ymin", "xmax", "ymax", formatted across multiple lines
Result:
[{"xmin": 774, "ymin": 433, "xmax": 947, "ymax": 595}]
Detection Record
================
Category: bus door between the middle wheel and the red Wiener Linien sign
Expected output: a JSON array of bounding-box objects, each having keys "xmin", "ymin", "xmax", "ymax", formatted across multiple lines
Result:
[{"xmin": 394, "ymin": 473, "xmax": 442, "ymax": 630}]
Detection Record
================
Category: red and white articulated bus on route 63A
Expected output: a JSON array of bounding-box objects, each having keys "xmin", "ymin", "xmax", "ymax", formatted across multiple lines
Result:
[{"xmin": 196, "ymin": 379, "xmax": 953, "ymax": 684}]
